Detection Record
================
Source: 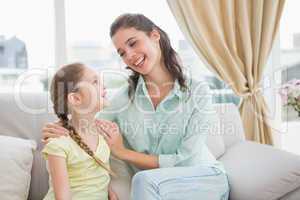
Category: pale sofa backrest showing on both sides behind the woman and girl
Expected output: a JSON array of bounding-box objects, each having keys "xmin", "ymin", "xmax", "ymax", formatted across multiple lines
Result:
[{"xmin": 0, "ymin": 92, "xmax": 244, "ymax": 200}]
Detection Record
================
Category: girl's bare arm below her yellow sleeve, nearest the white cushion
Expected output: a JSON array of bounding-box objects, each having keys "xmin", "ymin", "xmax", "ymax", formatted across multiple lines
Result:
[{"xmin": 48, "ymin": 155, "xmax": 72, "ymax": 200}]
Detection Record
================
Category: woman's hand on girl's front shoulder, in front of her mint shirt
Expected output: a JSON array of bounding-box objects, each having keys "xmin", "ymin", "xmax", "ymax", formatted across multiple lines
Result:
[{"xmin": 96, "ymin": 120, "xmax": 126, "ymax": 159}]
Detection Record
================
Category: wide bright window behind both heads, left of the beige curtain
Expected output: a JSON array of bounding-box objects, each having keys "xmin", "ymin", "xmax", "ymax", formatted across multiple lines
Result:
[{"xmin": 0, "ymin": 0, "xmax": 239, "ymax": 104}]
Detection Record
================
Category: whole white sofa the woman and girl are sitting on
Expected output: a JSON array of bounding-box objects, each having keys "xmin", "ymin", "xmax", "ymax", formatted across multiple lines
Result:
[{"xmin": 0, "ymin": 93, "xmax": 300, "ymax": 200}]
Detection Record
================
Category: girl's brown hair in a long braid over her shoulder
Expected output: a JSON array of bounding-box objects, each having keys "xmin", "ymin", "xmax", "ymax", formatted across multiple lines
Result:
[{"xmin": 50, "ymin": 63, "xmax": 116, "ymax": 176}]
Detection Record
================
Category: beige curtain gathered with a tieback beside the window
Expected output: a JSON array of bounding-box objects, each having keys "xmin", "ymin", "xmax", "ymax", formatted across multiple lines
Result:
[{"xmin": 168, "ymin": 0, "xmax": 285, "ymax": 144}]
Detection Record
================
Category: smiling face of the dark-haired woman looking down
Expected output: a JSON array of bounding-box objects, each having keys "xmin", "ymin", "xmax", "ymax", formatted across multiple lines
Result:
[{"xmin": 112, "ymin": 28, "xmax": 161, "ymax": 75}]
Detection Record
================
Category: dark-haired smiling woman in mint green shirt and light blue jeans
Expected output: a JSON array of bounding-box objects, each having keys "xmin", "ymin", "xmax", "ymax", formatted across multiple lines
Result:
[{"xmin": 44, "ymin": 14, "xmax": 229, "ymax": 200}]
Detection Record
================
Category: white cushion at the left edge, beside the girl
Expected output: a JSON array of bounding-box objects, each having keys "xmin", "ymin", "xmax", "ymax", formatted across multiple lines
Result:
[{"xmin": 0, "ymin": 136, "xmax": 36, "ymax": 200}]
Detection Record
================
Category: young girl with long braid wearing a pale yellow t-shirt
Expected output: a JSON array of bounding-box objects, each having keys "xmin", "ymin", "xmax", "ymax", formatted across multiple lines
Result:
[{"xmin": 42, "ymin": 63, "xmax": 117, "ymax": 200}]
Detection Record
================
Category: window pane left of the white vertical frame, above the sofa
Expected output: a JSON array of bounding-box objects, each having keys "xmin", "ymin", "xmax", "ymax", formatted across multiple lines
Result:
[{"xmin": 0, "ymin": 0, "xmax": 54, "ymax": 91}]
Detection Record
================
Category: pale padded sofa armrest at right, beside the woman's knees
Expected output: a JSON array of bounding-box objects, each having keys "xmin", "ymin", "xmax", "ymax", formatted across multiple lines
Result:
[{"xmin": 220, "ymin": 141, "xmax": 300, "ymax": 200}]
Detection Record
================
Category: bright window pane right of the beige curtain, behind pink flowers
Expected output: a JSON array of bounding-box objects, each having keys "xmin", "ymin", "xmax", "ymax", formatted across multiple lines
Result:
[{"xmin": 280, "ymin": 0, "xmax": 300, "ymax": 154}]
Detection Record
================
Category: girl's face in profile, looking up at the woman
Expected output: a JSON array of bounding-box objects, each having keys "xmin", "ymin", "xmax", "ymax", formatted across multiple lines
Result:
[{"xmin": 71, "ymin": 67, "xmax": 108, "ymax": 114}]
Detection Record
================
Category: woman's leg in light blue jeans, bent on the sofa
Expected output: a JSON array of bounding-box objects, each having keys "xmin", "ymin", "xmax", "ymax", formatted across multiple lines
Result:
[{"xmin": 131, "ymin": 166, "xmax": 229, "ymax": 200}]
